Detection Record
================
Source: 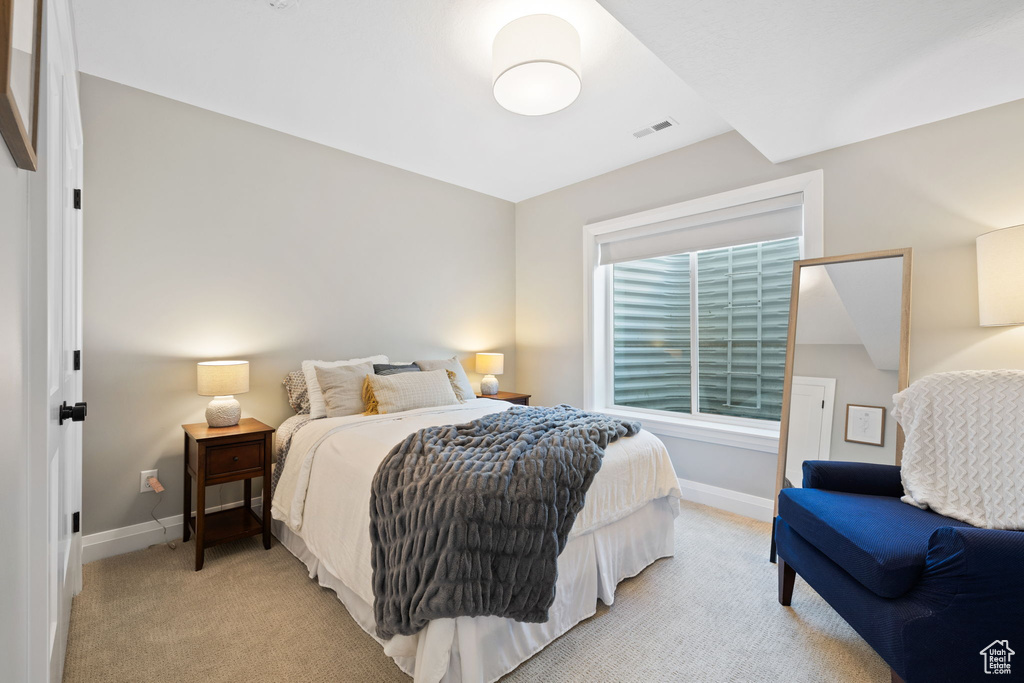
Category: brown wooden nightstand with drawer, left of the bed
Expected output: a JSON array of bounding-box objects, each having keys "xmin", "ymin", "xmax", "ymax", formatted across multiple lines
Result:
[{"xmin": 181, "ymin": 418, "xmax": 274, "ymax": 571}]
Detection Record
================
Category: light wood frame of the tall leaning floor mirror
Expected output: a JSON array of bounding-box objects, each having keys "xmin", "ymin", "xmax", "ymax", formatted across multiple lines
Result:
[{"xmin": 771, "ymin": 248, "xmax": 913, "ymax": 528}]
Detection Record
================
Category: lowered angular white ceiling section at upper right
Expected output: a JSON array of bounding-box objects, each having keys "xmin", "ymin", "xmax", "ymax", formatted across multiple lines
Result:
[{"xmin": 600, "ymin": 0, "xmax": 1024, "ymax": 163}]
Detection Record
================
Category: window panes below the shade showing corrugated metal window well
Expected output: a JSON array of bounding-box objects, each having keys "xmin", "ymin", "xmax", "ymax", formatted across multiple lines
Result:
[{"xmin": 611, "ymin": 238, "xmax": 800, "ymax": 420}]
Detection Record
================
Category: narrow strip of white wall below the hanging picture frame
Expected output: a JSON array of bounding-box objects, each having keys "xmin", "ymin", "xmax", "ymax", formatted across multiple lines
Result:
[{"xmin": 0, "ymin": 141, "xmax": 31, "ymax": 681}]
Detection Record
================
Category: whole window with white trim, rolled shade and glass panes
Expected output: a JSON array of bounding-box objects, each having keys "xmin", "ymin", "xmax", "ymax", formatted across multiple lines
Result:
[{"xmin": 584, "ymin": 171, "xmax": 822, "ymax": 452}]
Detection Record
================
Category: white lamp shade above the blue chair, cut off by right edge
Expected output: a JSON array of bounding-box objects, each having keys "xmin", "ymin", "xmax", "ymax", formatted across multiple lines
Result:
[{"xmin": 977, "ymin": 225, "xmax": 1024, "ymax": 328}]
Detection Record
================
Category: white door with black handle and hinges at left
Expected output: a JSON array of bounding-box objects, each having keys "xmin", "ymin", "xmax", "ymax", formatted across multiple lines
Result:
[{"xmin": 46, "ymin": 61, "xmax": 84, "ymax": 682}]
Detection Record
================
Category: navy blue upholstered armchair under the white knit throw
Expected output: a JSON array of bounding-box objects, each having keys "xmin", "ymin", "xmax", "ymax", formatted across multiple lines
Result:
[{"xmin": 775, "ymin": 461, "xmax": 1024, "ymax": 683}]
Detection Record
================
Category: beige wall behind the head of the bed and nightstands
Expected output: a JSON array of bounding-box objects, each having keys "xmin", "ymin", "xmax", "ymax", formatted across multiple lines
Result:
[{"xmin": 82, "ymin": 76, "xmax": 515, "ymax": 533}]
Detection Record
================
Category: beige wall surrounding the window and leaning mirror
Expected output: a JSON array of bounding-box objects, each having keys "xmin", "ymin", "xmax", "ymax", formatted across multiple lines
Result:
[{"xmin": 516, "ymin": 100, "xmax": 1024, "ymax": 497}]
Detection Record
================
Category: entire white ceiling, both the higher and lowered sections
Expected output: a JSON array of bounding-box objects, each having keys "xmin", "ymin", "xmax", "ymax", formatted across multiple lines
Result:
[{"xmin": 74, "ymin": 0, "xmax": 1024, "ymax": 201}]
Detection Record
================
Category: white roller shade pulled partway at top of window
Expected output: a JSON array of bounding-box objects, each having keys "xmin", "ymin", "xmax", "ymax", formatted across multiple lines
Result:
[{"xmin": 597, "ymin": 193, "xmax": 804, "ymax": 265}]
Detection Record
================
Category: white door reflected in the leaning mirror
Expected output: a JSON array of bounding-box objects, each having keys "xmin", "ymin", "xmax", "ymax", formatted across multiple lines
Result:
[{"xmin": 785, "ymin": 377, "xmax": 836, "ymax": 486}]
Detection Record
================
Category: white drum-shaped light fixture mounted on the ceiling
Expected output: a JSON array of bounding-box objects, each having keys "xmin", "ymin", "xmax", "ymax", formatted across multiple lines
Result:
[{"xmin": 494, "ymin": 14, "xmax": 583, "ymax": 116}]
